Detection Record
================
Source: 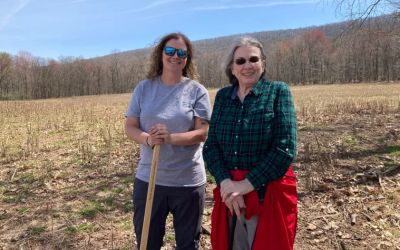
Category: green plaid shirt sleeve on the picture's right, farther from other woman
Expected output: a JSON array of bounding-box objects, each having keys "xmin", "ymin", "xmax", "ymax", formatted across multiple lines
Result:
[{"xmin": 246, "ymin": 83, "xmax": 297, "ymax": 189}]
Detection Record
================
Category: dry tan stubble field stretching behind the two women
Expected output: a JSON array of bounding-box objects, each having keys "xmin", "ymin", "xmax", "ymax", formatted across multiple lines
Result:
[{"xmin": 0, "ymin": 83, "xmax": 400, "ymax": 250}]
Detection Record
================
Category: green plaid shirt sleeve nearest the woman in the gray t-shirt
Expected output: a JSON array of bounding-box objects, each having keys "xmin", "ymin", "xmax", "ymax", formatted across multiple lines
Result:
[{"xmin": 203, "ymin": 91, "xmax": 231, "ymax": 185}]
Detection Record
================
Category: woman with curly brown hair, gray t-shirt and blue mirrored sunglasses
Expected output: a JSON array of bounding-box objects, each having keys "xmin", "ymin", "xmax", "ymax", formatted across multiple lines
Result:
[{"xmin": 125, "ymin": 33, "xmax": 211, "ymax": 250}]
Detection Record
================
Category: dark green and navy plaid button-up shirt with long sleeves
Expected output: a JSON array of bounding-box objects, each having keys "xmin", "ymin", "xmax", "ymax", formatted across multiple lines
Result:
[{"xmin": 203, "ymin": 80, "xmax": 297, "ymax": 197}]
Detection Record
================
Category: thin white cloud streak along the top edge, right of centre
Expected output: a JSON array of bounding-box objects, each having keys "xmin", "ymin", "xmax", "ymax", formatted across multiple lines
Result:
[{"xmin": 192, "ymin": 0, "xmax": 320, "ymax": 10}]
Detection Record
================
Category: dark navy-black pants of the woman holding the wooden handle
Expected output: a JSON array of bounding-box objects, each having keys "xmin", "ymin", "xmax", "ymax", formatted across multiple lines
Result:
[{"xmin": 133, "ymin": 179, "xmax": 205, "ymax": 250}]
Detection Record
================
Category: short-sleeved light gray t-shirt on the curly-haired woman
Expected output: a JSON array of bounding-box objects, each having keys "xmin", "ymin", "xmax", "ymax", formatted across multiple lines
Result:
[{"xmin": 126, "ymin": 77, "xmax": 211, "ymax": 187}]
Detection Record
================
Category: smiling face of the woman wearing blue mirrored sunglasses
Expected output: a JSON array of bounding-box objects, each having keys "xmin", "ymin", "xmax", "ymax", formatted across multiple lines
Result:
[{"xmin": 162, "ymin": 39, "xmax": 187, "ymax": 75}]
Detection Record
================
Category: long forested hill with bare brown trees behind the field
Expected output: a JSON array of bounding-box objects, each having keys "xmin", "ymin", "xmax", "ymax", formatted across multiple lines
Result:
[{"xmin": 0, "ymin": 15, "xmax": 400, "ymax": 100}]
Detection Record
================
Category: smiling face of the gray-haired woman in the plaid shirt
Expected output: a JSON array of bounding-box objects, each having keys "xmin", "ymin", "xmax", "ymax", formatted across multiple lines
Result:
[{"xmin": 231, "ymin": 46, "xmax": 264, "ymax": 87}]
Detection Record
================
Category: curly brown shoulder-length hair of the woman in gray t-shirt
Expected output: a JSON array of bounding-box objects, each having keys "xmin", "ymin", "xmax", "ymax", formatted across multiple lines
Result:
[{"xmin": 146, "ymin": 32, "xmax": 199, "ymax": 80}]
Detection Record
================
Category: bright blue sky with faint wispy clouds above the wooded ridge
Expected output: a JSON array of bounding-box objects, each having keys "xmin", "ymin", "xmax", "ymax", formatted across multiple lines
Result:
[{"xmin": 0, "ymin": 0, "xmax": 344, "ymax": 59}]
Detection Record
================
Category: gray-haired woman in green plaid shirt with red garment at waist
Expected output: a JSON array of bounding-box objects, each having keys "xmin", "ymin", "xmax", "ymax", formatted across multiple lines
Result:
[{"xmin": 203, "ymin": 37, "xmax": 297, "ymax": 250}]
